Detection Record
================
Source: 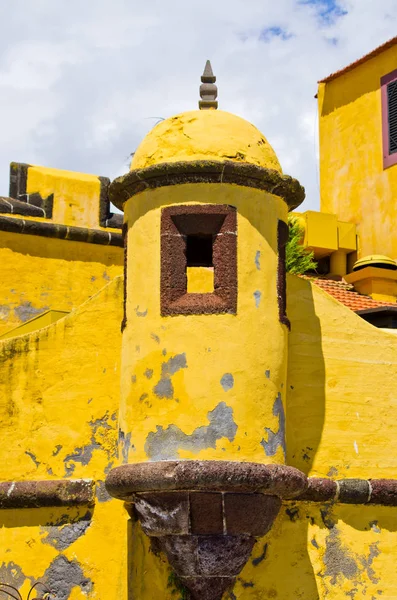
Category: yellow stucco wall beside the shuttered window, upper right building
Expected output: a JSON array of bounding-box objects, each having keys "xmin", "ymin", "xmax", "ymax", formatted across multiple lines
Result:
[{"xmin": 318, "ymin": 45, "xmax": 397, "ymax": 259}]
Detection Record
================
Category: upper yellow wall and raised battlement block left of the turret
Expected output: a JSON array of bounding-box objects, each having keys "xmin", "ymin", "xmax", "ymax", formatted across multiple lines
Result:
[{"xmin": 0, "ymin": 163, "xmax": 123, "ymax": 335}]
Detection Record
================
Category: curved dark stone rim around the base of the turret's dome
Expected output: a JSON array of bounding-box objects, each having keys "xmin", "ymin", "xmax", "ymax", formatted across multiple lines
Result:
[{"xmin": 109, "ymin": 160, "xmax": 305, "ymax": 210}]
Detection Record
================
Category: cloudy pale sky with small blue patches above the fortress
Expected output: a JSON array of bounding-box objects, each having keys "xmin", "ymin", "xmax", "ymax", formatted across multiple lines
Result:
[{"xmin": 0, "ymin": 0, "xmax": 397, "ymax": 209}]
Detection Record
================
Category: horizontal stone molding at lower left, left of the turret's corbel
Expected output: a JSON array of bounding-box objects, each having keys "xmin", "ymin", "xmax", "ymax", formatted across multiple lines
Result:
[{"xmin": 0, "ymin": 479, "xmax": 95, "ymax": 509}]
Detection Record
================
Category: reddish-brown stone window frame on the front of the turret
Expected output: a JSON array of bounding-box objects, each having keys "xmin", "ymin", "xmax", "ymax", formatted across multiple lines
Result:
[{"xmin": 160, "ymin": 204, "xmax": 237, "ymax": 316}]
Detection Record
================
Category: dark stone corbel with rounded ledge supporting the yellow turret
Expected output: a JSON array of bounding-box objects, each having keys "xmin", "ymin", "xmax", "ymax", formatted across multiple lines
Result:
[{"xmin": 106, "ymin": 461, "xmax": 307, "ymax": 600}]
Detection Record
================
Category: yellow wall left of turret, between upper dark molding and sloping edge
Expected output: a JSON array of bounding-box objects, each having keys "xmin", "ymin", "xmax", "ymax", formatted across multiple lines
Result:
[{"xmin": 0, "ymin": 231, "xmax": 123, "ymax": 335}]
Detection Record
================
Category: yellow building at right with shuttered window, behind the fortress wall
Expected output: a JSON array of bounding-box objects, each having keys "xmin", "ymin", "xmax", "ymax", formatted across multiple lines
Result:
[{"xmin": 297, "ymin": 38, "xmax": 397, "ymax": 327}]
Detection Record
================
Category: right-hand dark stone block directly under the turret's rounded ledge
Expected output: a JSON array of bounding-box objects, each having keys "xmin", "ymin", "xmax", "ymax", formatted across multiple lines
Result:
[{"xmin": 224, "ymin": 494, "xmax": 281, "ymax": 536}]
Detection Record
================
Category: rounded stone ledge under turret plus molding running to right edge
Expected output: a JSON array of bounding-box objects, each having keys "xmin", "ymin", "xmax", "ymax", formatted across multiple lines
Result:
[{"xmin": 106, "ymin": 460, "xmax": 397, "ymax": 506}]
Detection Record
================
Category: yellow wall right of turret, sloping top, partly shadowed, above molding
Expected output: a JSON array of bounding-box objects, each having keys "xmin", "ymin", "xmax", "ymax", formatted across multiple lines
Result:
[{"xmin": 287, "ymin": 276, "xmax": 397, "ymax": 479}]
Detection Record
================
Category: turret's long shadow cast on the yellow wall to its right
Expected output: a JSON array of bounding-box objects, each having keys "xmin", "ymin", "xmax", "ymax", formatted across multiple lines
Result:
[{"xmin": 283, "ymin": 275, "xmax": 325, "ymax": 600}]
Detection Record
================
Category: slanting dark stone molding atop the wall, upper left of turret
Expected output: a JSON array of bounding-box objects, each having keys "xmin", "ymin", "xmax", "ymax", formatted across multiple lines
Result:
[{"xmin": 0, "ymin": 216, "xmax": 123, "ymax": 248}]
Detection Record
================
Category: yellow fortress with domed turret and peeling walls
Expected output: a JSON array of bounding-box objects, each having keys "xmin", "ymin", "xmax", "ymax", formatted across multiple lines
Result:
[{"xmin": 0, "ymin": 56, "xmax": 397, "ymax": 600}]
